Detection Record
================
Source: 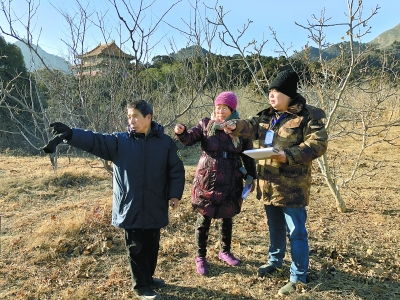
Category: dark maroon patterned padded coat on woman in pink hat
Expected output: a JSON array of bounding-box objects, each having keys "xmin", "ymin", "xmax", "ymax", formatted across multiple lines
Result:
[{"xmin": 176, "ymin": 118, "xmax": 256, "ymax": 218}]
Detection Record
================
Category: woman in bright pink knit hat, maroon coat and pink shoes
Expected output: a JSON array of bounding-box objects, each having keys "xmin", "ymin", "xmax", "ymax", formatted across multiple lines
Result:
[{"xmin": 174, "ymin": 92, "xmax": 256, "ymax": 275}]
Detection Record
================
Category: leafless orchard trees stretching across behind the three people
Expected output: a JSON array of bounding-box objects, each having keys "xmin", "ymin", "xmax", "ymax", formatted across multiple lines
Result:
[{"xmin": 0, "ymin": 0, "xmax": 399, "ymax": 211}]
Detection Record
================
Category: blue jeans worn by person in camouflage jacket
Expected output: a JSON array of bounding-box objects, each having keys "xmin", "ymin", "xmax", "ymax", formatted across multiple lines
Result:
[{"xmin": 264, "ymin": 205, "xmax": 309, "ymax": 283}]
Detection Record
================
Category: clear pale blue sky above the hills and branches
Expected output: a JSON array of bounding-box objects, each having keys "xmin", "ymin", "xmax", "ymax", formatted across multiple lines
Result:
[{"xmin": 0, "ymin": 0, "xmax": 400, "ymax": 58}]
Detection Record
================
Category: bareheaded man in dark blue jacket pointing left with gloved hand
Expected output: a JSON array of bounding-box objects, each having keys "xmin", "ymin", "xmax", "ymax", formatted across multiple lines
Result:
[{"xmin": 43, "ymin": 100, "xmax": 185, "ymax": 299}]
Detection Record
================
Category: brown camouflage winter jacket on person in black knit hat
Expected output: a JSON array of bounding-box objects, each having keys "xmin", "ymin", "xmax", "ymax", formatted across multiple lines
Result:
[{"xmin": 232, "ymin": 94, "xmax": 328, "ymax": 207}]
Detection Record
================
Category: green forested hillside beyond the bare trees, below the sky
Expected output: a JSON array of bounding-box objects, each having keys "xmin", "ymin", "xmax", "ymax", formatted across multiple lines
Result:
[{"xmin": 0, "ymin": 37, "xmax": 400, "ymax": 154}]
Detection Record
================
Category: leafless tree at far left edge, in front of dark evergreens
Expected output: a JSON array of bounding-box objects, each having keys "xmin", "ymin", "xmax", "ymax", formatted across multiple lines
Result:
[{"xmin": 0, "ymin": 0, "xmax": 62, "ymax": 166}]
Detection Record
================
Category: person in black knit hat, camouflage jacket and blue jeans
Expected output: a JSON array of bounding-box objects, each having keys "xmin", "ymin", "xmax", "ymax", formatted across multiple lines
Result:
[{"xmin": 223, "ymin": 70, "xmax": 328, "ymax": 295}]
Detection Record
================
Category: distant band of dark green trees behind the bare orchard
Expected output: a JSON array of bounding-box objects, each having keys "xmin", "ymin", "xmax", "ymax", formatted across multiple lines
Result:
[{"xmin": 0, "ymin": 37, "xmax": 400, "ymax": 153}]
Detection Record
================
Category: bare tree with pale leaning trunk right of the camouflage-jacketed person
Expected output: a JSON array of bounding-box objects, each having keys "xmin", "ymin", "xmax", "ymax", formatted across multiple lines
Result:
[{"xmin": 299, "ymin": 0, "xmax": 400, "ymax": 212}]
